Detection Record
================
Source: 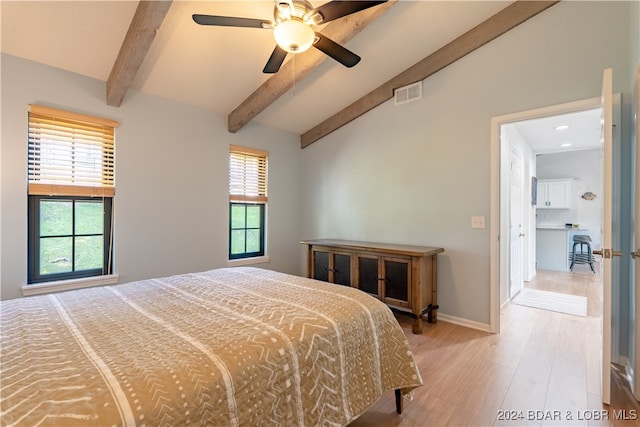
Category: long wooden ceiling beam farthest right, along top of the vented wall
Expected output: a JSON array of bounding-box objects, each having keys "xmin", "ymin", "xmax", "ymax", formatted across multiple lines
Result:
[{"xmin": 300, "ymin": 1, "xmax": 558, "ymax": 148}]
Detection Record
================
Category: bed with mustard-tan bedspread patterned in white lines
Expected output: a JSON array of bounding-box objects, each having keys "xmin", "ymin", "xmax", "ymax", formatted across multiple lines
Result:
[{"xmin": 0, "ymin": 267, "xmax": 422, "ymax": 426}]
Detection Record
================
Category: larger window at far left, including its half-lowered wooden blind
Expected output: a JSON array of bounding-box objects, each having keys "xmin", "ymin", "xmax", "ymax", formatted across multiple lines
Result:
[{"xmin": 28, "ymin": 105, "xmax": 117, "ymax": 283}]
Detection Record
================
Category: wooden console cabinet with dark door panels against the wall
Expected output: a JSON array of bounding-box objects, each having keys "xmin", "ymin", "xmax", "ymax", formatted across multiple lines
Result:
[{"xmin": 300, "ymin": 239, "xmax": 444, "ymax": 334}]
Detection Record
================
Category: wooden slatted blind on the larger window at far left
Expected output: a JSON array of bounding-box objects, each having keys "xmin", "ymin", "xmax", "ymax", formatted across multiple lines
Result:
[{"xmin": 28, "ymin": 105, "xmax": 118, "ymax": 197}]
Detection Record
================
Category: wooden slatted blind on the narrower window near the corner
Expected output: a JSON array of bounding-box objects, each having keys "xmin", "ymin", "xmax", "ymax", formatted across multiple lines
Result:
[{"xmin": 229, "ymin": 145, "xmax": 269, "ymax": 203}]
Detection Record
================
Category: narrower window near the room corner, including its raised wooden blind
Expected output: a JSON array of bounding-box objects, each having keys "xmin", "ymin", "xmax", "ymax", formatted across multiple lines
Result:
[{"xmin": 229, "ymin": 145, "xmax": 268, "ymax": 259}]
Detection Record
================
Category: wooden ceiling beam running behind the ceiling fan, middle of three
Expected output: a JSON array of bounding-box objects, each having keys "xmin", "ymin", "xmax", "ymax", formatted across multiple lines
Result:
[{"xmin": 227, "ymin": 0, "xmax": 397, "ymax": 133}]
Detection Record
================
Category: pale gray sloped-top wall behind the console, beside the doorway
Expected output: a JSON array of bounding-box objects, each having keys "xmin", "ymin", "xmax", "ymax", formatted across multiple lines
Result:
[{"xmin": 303, "ymin": 2, "xmax": 631, "ymax": 325}]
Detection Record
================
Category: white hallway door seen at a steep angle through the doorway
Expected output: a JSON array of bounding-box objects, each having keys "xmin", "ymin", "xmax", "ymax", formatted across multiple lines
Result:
[{"xmin": 509, "ymin": 149, "xmax": 524, "ymax": 298}]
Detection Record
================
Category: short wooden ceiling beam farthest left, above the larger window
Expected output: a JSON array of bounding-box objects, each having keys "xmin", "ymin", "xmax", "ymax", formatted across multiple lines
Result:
[{"xmin": 107, "ymin": 0, "xmax": 172, "ymax": 107}]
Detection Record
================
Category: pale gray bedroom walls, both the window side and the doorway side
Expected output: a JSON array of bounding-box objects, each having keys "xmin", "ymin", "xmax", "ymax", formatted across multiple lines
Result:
[{"xmin": 0, "ymin": 2, "xmax": 640, "ymax": 332}]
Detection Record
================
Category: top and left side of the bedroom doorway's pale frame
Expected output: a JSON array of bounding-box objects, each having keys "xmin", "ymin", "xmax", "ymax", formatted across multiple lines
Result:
[{"xmin": 489, "ymin": 95, "xmax": 604, "ymax": 336}]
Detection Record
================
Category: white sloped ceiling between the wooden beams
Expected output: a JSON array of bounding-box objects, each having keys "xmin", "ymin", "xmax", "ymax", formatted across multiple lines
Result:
[{"xmin": 1, "ymin": 0, "xmax": 510, "ymax": 134}]
